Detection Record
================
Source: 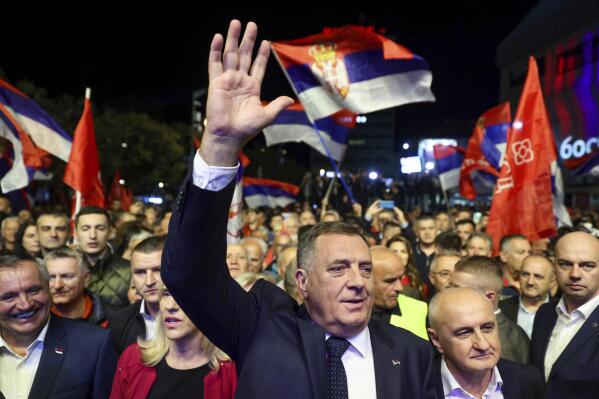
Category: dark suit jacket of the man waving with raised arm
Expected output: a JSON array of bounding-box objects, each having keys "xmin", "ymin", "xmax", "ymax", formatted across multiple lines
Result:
[{"xmin": 162, "ymin": 180, "xmax": 435, "ymax": 399}]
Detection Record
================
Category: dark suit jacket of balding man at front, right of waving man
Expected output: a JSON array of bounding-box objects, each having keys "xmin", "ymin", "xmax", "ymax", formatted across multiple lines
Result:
[{"xmin": 435, "ymin": 356, "xmax": 544, "ymax": 399}]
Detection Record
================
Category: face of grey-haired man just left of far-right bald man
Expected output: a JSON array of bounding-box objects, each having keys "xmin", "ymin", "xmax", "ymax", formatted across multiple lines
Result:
[{"xmin": 520, "ymin": 255, "xmax": 553, "ymax": 299}]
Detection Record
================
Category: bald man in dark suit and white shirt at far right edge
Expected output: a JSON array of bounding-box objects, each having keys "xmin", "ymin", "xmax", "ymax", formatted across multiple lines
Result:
[{"xmin": 531, "ymin": 232, "xmax": 599, "ymax": 399}]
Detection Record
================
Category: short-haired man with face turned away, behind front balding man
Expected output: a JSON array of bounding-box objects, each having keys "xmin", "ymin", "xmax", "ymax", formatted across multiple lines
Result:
[{"xmin": 450, "ymin": 256, "xmax": 530, "ymax": 363}]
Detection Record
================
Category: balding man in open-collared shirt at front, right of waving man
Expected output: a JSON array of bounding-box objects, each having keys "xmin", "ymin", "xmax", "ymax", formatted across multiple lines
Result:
[{"xmin": 428, "ymin": 288, "xmax": 543, "ymax": 399}]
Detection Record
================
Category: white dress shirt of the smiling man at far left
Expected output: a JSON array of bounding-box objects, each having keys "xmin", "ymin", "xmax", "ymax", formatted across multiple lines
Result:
[{"xmin": 0, "ymin": 319, "xmax": 50, "ymax": 399}]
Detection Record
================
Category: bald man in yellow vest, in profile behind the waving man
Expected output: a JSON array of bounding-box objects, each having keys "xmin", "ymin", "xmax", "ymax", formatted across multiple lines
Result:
[{"xmin": 370, "ymin": 246, "xmax": 428, "ymax": 339}]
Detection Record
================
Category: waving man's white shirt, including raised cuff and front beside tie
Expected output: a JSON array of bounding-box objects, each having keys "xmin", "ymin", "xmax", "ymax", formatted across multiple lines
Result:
[{"xmin": 192, "ymin": 152, "xmax": 376, "ymax": 399}]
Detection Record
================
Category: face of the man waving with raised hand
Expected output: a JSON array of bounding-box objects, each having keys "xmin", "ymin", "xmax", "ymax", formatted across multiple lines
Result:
[{"xmin": 296, "ymin": 234, "xmax": 373, "ymax": 337}]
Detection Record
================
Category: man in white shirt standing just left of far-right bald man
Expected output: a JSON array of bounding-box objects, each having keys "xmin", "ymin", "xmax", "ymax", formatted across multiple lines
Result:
[{"xmin": 499, "ymin": 255, "xmax": 554, "ymax": 338}]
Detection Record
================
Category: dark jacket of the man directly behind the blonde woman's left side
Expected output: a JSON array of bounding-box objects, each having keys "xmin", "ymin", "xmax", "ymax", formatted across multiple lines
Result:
[{"xmin": 108, "ymin": 301, "xmax": 146, "ymax": 354}]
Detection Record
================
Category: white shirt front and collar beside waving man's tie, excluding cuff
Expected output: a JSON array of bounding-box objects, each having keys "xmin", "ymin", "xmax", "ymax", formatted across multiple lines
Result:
[{"xmin": 325, "ymin": 327, "xmax": 376, "ymax": 399}]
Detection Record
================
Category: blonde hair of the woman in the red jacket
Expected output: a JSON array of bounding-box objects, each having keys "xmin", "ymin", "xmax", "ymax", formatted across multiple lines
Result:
[{"xmin": 137, "ymin": 286, "xmax": 230, "ymax": 371}]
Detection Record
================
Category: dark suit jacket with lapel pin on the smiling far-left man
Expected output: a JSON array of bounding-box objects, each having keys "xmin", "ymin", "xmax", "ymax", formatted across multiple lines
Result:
[{"xmin": 29, "ymin": 315, "xmax": 117, "ymax": 399}]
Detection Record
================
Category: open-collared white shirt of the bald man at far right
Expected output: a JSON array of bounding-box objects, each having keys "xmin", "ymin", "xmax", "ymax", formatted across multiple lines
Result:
[{"xmin": 545, "ymin": 295, "xmax": 599, "ymax": 380}]
